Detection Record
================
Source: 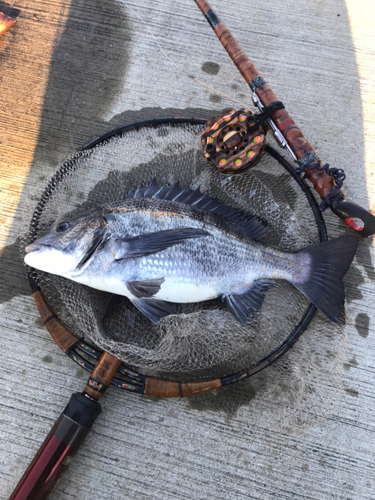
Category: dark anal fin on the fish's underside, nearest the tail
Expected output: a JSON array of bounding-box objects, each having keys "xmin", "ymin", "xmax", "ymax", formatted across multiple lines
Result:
[{"xmin": 223, "ymin": 279, "xmax": 275, "ymax": 325}]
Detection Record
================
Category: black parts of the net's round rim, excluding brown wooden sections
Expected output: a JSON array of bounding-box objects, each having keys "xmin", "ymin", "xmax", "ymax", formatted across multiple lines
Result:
[{"xmin": 29, "ymin": 117, "xmax": 328, "ymax": 393}]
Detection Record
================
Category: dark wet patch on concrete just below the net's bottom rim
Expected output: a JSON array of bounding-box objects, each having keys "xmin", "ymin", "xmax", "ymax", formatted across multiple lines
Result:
[{"xmin": 187, "ymin": 380, "xmax": 255, "ymax": 417}]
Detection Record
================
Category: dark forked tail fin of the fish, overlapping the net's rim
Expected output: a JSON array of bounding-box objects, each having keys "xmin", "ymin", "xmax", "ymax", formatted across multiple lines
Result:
[{"xmin": 293, "ymin": 234, "xmax": 359, "ymax": 324}]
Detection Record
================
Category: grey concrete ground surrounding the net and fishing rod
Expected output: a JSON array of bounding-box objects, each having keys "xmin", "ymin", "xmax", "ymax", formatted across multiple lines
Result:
[{"xmin": 0, "ymin": 0, "xmax": 375, "ymax": 500}]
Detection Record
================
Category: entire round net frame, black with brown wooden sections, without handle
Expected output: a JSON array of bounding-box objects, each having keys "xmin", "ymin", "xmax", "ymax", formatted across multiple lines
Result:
[{"xmin": 29, "ymin": 117, "xmax": 328, "ymax": 397}]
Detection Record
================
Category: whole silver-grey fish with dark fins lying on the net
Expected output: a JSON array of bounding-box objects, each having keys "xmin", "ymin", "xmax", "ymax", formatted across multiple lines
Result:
[{"xmin": 24, "ymin": 179, "xmax": 359, "ymax": 325}]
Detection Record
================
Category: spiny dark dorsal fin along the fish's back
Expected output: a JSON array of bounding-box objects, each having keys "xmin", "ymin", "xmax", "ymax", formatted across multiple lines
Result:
[{"xmin": 125, "ymin": 178, "xmax": 270, "ymax": 240}]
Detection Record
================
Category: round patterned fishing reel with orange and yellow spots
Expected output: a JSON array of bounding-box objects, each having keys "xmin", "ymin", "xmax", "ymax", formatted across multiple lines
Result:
[{"xmin": 202, "ymin": 108, "xmax": 266, "ymax": 174}]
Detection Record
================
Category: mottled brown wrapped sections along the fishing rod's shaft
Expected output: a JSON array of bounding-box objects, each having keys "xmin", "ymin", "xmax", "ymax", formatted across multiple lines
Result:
[{"xmin": 196, "ymin": 0, "xmax": 335, "ymax": 199}]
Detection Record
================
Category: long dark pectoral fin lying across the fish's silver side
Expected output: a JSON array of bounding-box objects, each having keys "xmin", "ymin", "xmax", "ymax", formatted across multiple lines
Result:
[{"xmin": 115, "ymin": 228, "xmax": 210, "ymax": 260}]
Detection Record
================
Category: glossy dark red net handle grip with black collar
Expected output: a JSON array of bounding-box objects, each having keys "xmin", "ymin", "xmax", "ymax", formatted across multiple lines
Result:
[{"xmin": 9, "ymin": 393, "xmax": 102, "ymax": 500}]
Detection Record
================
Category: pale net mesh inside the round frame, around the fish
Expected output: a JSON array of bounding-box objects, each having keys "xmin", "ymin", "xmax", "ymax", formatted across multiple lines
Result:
[{"xmin": 25, "ymin": 123, "xmax": 319, "ymax": 378}]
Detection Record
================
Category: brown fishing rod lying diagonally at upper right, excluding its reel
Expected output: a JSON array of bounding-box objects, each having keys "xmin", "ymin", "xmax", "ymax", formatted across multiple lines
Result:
[{"xmin": 195, "ymin": 0, "xmax": 375, "ymax": 237}]
